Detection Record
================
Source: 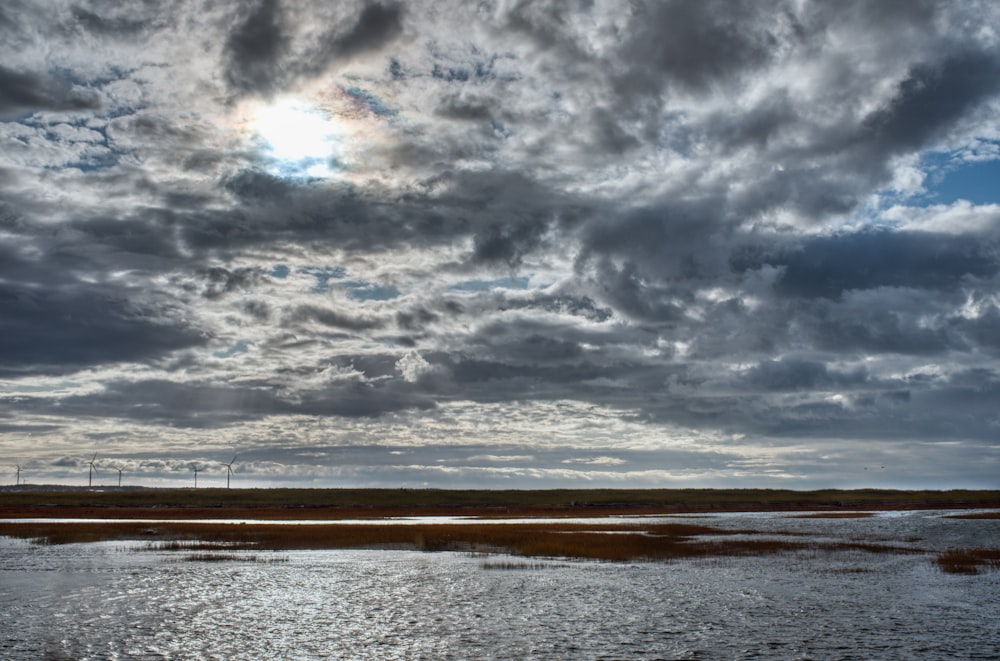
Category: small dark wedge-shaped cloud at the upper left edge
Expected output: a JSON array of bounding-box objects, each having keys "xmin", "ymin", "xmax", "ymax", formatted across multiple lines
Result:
[{"xmin": 0, "ymin": 64, "xmax": 101, "ymax": 117}]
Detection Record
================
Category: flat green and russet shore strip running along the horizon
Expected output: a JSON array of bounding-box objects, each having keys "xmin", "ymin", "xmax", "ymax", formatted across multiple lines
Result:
[{"xmin": 0, "ymin": 487, "xmax": 1000, "ymax": 521}]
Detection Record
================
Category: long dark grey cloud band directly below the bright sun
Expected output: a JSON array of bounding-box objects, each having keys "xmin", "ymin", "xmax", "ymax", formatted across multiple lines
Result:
[{"xmin": 188, "ymin": 169, "xmax": 594, "ymax": 267}]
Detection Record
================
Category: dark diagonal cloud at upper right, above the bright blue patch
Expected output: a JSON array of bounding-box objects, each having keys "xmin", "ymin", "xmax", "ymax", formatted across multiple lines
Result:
[{"xmin": 744, "ymin": 45, "xmax": 1000, "ymax": 219}]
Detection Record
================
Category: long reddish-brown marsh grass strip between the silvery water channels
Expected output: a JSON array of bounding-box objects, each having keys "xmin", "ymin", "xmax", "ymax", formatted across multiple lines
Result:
[{"xmin": 0, "ymin": 521, "xmax": 916, "ymax": 562}]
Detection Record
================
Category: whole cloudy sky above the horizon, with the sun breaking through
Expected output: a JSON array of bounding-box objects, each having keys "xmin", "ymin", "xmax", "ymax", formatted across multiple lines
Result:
[{"xmin": 0, "ymin": 0, "xmax": 1000, "ymax": 489}]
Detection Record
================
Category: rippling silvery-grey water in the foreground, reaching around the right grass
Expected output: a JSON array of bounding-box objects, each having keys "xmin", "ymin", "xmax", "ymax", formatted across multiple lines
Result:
[{"xmin": 0, "ymin": 512, "xmax": 1000, "ymax": 659}]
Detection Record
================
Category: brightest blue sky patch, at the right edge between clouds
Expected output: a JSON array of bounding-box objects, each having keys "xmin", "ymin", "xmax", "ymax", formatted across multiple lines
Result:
[{"xmin": 924, "ymin": 153, "xmax": 1000, "ymax": 204}]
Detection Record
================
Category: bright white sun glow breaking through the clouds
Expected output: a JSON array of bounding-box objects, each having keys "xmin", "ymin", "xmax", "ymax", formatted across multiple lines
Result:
[{"xmin": 253, "ymin": 100, "xmax": 342, "ymax": 177}]
